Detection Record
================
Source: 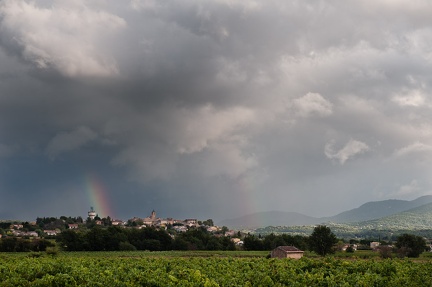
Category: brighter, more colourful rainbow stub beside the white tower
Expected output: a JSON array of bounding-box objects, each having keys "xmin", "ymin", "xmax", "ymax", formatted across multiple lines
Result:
[{"xmin": 85, "ymin": 174, "xmax": 114, "ymax": 218}]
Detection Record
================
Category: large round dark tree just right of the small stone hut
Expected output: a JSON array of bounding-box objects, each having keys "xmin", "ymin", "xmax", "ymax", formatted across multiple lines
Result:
[{"xmin": 309, "ymin": 225, "xmax": 338, "ymax": 256}]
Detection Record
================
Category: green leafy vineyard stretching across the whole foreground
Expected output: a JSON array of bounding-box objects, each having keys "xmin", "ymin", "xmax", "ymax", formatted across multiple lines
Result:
[{"xmin": 0, "ymin": 253, "xmax": 432, "ymax": 287}]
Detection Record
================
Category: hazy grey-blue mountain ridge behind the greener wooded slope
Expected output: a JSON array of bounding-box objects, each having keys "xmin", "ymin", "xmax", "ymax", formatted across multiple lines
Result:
[{"xmin": 218, "ymin": 195, "xmax": 432, "ymax": 229}]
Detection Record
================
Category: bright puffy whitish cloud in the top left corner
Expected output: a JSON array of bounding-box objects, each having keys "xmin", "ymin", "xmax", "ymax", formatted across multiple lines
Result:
[{"xmin": 0, "ymin": 0, "xmax": 126, "ymax": 77}]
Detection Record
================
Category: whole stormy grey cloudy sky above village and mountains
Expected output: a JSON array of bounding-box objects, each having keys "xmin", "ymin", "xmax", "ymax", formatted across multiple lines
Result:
[{"xmin": 0, "ymin": 0, "xmax": 432, "ymax": 221}]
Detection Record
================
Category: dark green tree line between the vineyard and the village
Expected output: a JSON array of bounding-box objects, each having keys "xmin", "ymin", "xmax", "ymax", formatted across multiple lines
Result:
[{"xmin": 0, "ymin": 225, "xmax": 427, "ymax": 257}]
